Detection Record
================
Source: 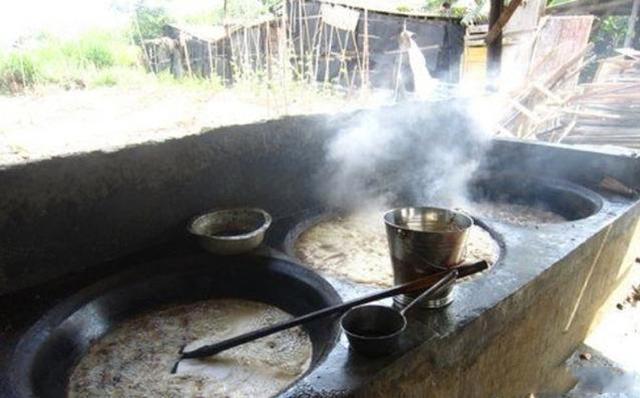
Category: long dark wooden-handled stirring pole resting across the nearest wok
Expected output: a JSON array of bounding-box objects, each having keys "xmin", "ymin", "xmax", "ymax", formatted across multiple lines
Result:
[{"xmin": 171, "ymin": 261, "xmax": 488, "ymax": 373}]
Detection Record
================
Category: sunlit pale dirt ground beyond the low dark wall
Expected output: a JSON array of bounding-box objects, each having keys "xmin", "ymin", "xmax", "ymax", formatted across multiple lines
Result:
[{"xmin": 0, "ymin": 84, "xmax": 380, "ymax": 167}]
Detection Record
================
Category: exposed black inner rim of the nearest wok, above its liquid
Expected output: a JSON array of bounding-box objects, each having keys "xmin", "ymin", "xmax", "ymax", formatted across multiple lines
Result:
[{"xmin": 9, "ymin": 254, "xmax": 341, "ymax": 398}]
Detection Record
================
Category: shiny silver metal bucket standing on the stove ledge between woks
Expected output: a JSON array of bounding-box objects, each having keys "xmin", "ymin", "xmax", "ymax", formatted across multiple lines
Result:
[{"xmin": 384, "ymin": 207, "xmax": 473, "ymax": 308}]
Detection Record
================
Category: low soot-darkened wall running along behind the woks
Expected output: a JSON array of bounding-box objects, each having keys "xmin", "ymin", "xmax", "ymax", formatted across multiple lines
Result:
[{"xmin": 0, "ymin": 105, "xmax": 640, "ymax": 294}]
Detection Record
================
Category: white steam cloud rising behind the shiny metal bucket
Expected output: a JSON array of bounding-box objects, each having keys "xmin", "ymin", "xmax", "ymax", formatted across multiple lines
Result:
[{"xmin": 323, "ymin": 90, "xmax": 493, "ymax": 209}]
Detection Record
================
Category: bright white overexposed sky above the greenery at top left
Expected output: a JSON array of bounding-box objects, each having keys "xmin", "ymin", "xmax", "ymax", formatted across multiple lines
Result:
[{"xmin": 0, "ymin": 0, "xmax": 222, "ymax": 49}]
